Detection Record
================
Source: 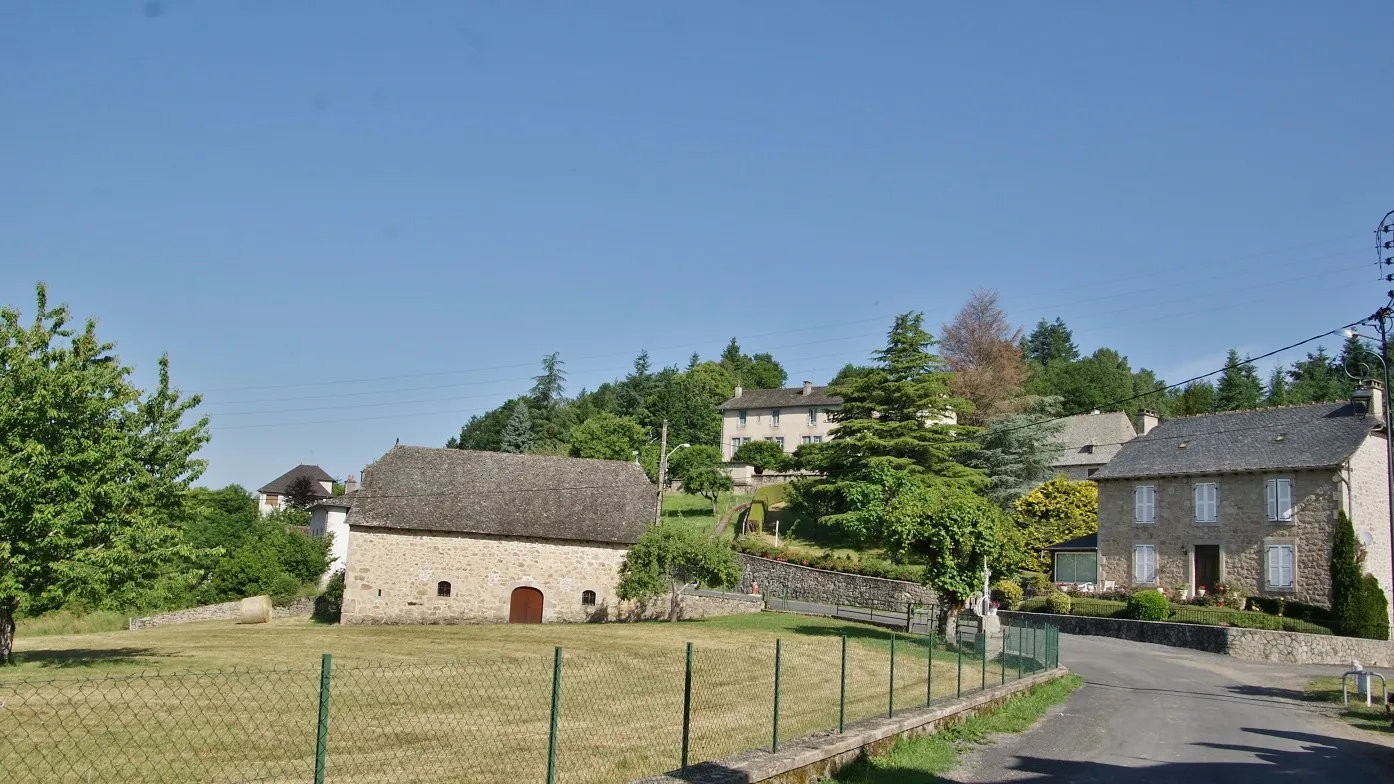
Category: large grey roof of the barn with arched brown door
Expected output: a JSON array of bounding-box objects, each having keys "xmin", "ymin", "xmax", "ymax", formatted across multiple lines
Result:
[{"xmin": 347, "ymin": 445, "xmax": 657, "ymax": 544}]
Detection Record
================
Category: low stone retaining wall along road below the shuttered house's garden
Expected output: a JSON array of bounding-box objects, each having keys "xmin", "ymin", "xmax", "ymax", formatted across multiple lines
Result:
[{"xmin": 998, "ymin": 611, "xmax": 1394, "ymax": 667}]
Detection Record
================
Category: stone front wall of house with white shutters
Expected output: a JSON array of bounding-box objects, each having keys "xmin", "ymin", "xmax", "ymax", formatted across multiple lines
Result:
[{"xmin": 1098, "ymin": 470, "xmax": 1344, "ymax": 607}]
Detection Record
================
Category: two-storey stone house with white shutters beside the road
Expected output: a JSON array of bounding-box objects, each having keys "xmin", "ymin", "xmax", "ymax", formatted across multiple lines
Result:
[{"xmin": 1093, "ymin": 389, "xmax": 1391, "ymax": 607}]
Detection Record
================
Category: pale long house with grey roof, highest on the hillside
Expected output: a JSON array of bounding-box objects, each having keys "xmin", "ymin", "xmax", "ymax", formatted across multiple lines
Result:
[{"xmin": 721, "ymin": 381, "xmax": 842, "ymax": 460}]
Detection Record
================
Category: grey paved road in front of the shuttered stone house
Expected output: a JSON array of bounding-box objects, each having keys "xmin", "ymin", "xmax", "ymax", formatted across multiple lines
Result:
[{"xmin": 942, "ymin": 635, "xmax": 1394, "ymax": 784}]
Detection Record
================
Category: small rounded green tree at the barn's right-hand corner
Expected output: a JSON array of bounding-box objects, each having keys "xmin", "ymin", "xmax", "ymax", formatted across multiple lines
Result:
[{"xmin": 615, "ymin": 523, "xmax": 740, "ymax": 621}]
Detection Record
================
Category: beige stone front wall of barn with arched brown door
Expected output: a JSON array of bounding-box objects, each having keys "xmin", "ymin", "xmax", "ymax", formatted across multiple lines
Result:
[{"xmin": 342, "ymin": 526, "xmax": 626, "ymax": 624}]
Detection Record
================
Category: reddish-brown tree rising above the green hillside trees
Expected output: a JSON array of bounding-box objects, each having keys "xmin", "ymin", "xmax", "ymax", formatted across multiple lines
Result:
[{"xmin": 940, "ymin": 289, "xmax": 1027, "ymax": 424}]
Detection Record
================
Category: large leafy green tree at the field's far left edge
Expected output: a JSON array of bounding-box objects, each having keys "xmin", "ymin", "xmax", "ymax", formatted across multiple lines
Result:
[{"xmin": 0, "ymin": 285, "xmax": 208, "ymax": 661}]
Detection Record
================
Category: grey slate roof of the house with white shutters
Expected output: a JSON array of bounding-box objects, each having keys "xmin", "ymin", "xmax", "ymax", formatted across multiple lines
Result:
[{"xmin": 1093, "ymin": 403, "xmax": 1383, "ymax": 481}]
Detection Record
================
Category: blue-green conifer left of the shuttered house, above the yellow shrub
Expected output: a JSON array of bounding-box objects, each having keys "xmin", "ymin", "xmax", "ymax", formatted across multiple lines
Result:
[{"xmin": 965, "ymin": 398, "xmax": 1065, "ymax": 509}]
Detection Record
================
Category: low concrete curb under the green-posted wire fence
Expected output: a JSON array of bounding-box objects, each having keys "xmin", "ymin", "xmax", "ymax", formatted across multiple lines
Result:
[{"xmin": 633, "ymin": 667, "xmax": 1069, "ymax": 784}]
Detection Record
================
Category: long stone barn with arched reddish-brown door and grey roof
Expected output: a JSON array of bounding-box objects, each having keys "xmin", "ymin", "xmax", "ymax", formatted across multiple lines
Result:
[{"xmin": 342, "ymin": 446, "xmax": 655, "ymax": 624}]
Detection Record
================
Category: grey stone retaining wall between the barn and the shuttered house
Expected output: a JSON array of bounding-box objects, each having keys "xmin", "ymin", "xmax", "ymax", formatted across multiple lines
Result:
[{"xmin": 736, "ymin": 552, "xmax": 934, "ymax": 610}]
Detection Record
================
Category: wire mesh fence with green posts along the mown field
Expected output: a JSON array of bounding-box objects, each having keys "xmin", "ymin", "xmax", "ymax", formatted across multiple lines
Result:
[{"xmin": 0, "ymin": 616, "xmax": 1058, "ymax": 784}]
